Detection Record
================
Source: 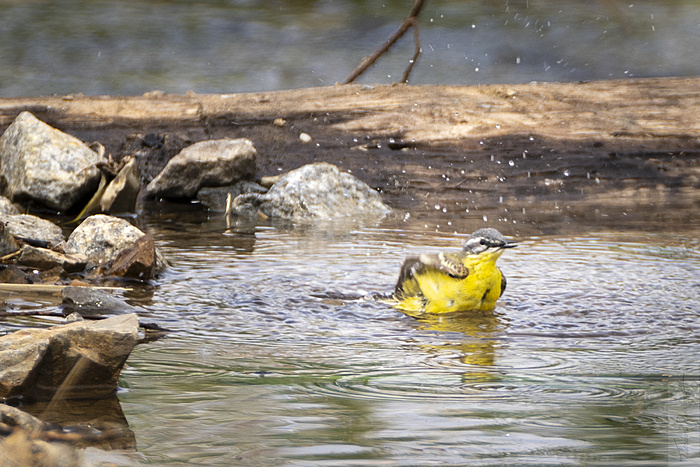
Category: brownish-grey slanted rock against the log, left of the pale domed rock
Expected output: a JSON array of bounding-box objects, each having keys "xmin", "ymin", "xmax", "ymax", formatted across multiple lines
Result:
[{"xmin": 146, "ymin": 138, "xmax": 256, "ymax": 199}]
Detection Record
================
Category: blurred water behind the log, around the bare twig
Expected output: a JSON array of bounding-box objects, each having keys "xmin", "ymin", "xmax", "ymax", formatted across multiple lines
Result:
[{"xmin": 0, "ymin": 0, "xmax": 700, "ymax": 97}]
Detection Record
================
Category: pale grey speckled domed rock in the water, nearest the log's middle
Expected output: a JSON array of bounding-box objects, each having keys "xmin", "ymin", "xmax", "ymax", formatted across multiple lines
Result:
[{"xmin": 232, "ymin": 162, "xmax": 390, "ymax": 220}]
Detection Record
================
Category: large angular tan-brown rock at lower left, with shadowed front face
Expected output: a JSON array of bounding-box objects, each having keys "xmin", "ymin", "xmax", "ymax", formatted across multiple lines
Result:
[{"xmin": 0, "ymin": 314, "xmax": 139, "ymax": 400}]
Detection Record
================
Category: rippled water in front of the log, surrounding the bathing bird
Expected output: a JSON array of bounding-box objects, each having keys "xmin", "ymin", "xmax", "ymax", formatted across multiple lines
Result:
[{"xmin": 5, "ymin": 211, "xmax": 700, "ymax": 466}]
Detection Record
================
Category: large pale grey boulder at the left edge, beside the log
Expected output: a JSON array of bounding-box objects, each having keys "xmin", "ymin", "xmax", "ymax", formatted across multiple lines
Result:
[{"xmin": 0, "ymin": 112, "xmax": 100, "ymax": 211}]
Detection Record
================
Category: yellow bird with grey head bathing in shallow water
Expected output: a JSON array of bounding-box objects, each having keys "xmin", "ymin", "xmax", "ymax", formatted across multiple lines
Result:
[{"xmin": 390, "ymin": 228, "xmax": 517, "ymax": 314}]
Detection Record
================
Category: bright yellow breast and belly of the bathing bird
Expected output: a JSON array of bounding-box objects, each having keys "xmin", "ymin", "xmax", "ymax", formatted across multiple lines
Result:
[{"xmin": 394, "ymin": 251, "xmax": 502, "ymax": 313}]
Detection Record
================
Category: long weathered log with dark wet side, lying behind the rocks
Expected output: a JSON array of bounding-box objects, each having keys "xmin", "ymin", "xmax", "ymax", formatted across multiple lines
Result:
[{"xmin": 0, "ymin": 78, "xmax": 700, "ymax": 233}]
